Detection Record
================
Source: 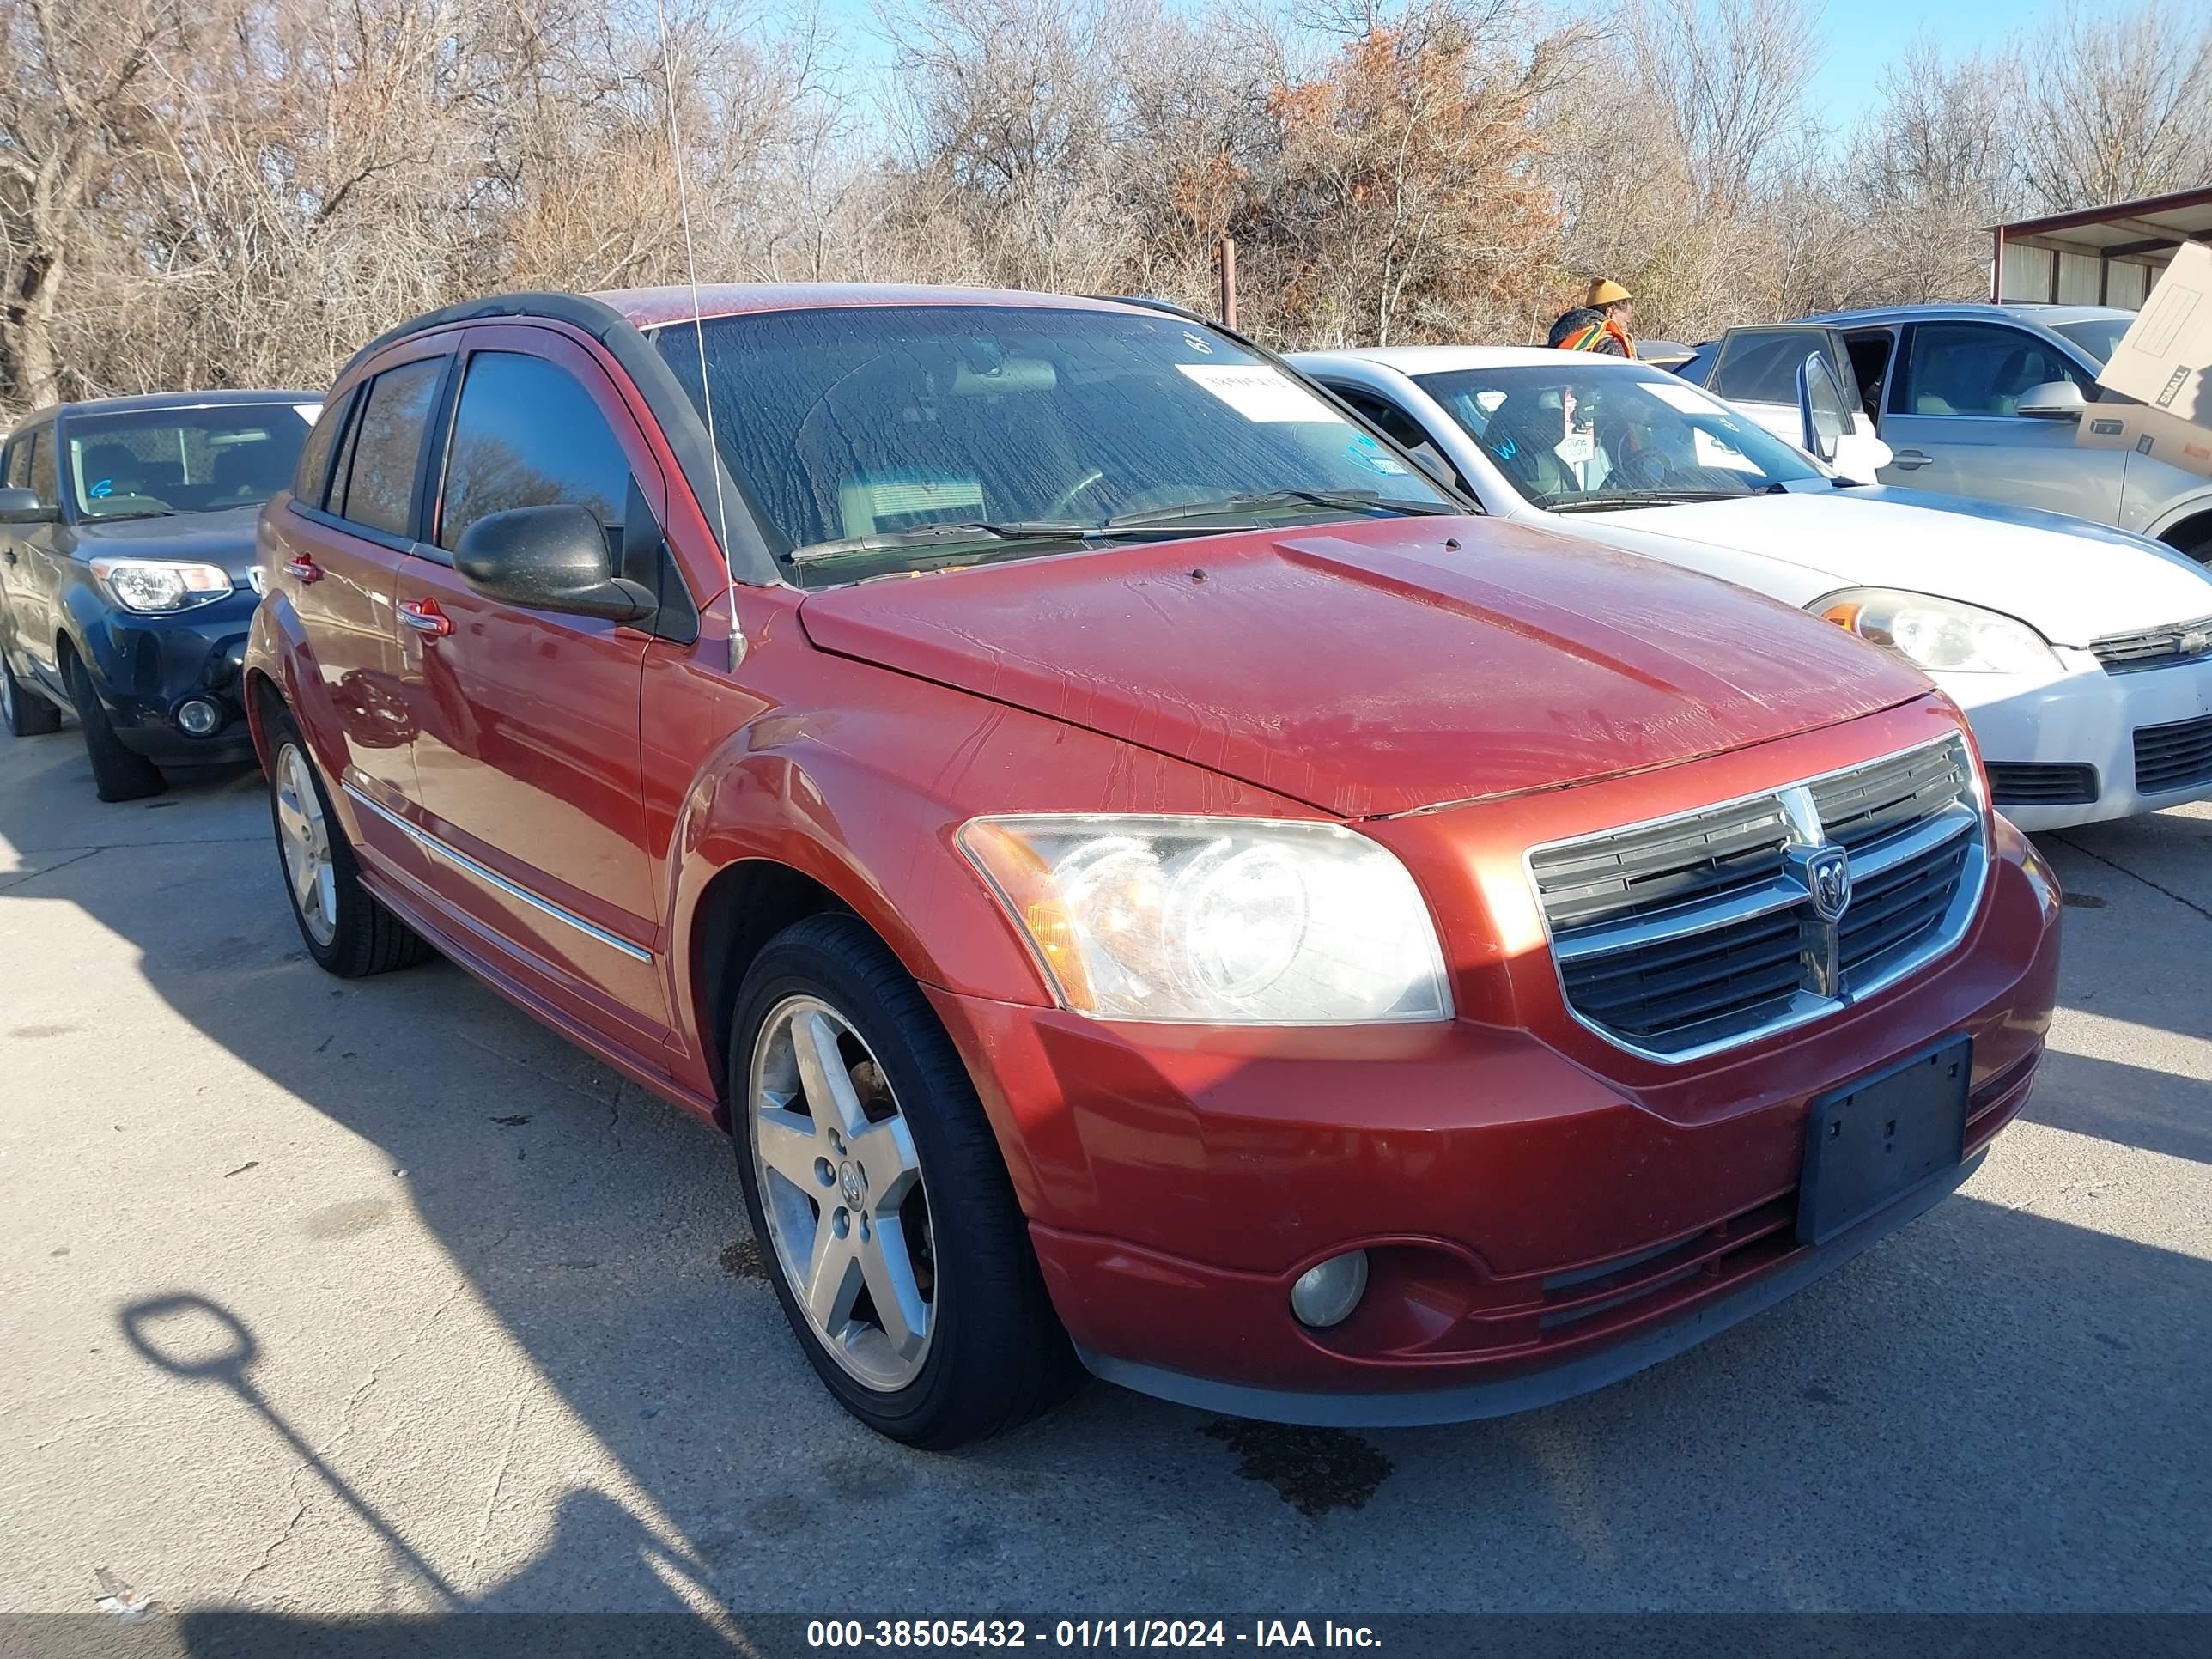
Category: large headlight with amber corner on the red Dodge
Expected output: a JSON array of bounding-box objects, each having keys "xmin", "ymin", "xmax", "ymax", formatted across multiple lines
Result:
[{"xmin": 960, "ymin": 817, "xmax": 1451, "ymax": 1026}]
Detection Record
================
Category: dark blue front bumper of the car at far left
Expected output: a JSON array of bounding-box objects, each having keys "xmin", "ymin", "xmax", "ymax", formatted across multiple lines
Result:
[{"xmin": 82, "ymin": 588, "xmax": 257, "ymax": 765}]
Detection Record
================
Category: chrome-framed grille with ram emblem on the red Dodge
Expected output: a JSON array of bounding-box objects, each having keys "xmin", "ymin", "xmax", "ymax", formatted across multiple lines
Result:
[{"xmin": 1528, "ymin": 738, "xmax": 1986, "ymax": 1060}]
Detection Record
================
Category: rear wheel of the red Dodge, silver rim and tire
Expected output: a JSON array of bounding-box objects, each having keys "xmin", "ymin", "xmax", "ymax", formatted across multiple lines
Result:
[{"xmin": 268, "ymin": 710, "xmax": 431, "ymax": 980}]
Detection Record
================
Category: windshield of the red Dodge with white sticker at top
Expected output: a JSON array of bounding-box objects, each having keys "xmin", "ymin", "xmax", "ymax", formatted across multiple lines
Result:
[{"xmin": 657, "ymin": 305, "xmax": 1462, "ymax": 581}]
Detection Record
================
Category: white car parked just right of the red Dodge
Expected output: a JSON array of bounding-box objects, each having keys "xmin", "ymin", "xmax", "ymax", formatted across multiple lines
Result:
[{"xmin": 1291, "ymin": 345, "xmax": 2212, "ymax": 830}]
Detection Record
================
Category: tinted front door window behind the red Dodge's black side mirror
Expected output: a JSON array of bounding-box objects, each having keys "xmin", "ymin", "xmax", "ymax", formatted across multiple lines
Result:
[{"xmin": 438, "ymin": 352, "xmax": 630, "ymax": 550}]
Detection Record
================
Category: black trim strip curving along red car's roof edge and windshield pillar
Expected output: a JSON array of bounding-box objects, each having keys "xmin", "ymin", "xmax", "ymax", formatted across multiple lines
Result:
[{"xmin": 338, "ymin": 292, "xmax": 783, "ymax": 586}]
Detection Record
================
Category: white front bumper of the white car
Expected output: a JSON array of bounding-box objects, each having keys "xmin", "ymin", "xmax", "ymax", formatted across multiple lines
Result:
[{"xmin": 1936, "ymin": 646, "xmax": 2212, "ymax": 830}]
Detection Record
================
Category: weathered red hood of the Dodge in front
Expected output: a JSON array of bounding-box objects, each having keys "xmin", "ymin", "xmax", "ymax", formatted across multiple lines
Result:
[{"xmin": 799, "ymin": 518, "xmax": 1927, "ymax": 818}]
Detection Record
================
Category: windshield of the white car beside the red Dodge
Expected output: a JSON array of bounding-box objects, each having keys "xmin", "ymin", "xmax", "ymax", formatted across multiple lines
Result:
[{"xmin": 1416, "ymin": 365, "xmax": 1827, "ymax": 511}]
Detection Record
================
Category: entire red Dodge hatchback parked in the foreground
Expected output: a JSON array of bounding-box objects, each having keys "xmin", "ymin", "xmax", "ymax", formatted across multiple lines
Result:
[{"xmin": 248, "ymin": 288, "xmax": 2057, "ymax": 1447}]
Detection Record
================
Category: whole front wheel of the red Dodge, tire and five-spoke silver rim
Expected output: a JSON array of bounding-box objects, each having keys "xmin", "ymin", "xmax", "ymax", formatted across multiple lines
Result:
[{"xmin": 730, "ymin": 915, "xmax": 1082, "ymax": 1451}]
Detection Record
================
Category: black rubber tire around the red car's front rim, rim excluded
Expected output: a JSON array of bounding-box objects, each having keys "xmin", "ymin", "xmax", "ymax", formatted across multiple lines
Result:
[{"xmin": 728, "ymin": 915, "xmax": 1066, "ymax": 1447}]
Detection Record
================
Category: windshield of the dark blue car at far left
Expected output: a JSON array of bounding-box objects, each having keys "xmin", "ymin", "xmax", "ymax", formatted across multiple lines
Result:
[{"xmin": 64, "ymin": 403, "xmax": 323, "ymax": 518}]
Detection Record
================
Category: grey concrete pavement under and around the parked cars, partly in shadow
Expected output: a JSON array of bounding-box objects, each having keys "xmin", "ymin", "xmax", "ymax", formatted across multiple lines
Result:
[{"xmin": 0, "ymin": 728, "xmax": 2212, "ymax": 1620}]
